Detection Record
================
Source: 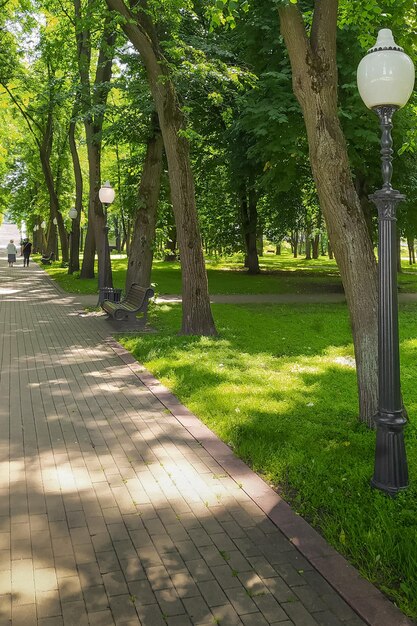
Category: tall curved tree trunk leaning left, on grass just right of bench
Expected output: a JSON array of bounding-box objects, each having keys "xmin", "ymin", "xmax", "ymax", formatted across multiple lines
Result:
[{"xmin": 106, "ymin": 0, "xmax": 217, "ymax": 335}]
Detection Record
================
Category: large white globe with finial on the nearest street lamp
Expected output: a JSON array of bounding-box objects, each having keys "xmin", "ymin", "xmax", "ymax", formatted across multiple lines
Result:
[{"xmin": 357, "ymin": 28, "xmax": 415, "ymax": 109}]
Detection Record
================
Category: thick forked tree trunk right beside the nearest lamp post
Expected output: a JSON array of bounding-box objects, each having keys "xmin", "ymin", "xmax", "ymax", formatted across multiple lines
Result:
[{"xmin": 279, "ymin": 0, "xmax": 378, "ymax": 425}]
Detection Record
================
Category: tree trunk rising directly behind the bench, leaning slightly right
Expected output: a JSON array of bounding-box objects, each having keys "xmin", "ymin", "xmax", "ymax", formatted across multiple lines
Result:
[{"xmin": 126, "ymin": 120, "xmax": 163, "ymax": 291}]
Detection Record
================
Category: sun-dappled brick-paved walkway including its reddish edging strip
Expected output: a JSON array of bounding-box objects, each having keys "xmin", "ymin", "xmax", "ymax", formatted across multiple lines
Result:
[{"xmin": 0, "ymin": 229, "xmax": 409, "ymax": 626}]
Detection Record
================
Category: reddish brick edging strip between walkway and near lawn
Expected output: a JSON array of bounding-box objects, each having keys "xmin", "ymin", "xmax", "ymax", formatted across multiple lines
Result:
[{"xmin": 106, "ymin": 337, "xmax": 415, "ymax": 626}]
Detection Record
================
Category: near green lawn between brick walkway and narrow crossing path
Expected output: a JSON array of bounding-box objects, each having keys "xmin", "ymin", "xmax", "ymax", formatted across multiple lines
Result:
[{"xmin": 118, "ymin": 304, "xmax": 417, "ymax": 617}]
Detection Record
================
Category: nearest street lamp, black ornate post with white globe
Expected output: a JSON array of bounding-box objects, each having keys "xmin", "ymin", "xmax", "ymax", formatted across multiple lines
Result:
[{"xmin": 357, "ymin": 28, "xmax": 414, "ymax": 496}]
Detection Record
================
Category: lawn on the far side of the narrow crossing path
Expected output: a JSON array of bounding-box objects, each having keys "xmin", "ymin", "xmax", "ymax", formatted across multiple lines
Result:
[{"xmin": 35, "ymin": 251, "xmax": 417, "ymax": 295}]
